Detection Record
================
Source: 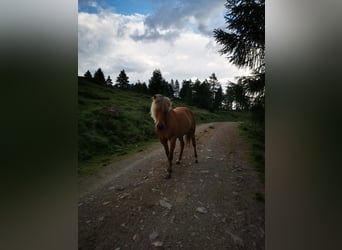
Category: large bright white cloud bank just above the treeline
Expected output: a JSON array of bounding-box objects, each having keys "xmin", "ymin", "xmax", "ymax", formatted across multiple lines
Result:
[{"xmin": 78, "ymin": 10, "xmax": 246, "ymax": 86}]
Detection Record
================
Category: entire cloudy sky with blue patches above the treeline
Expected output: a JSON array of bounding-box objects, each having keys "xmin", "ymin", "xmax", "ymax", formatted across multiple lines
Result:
[{"xmin": 78, "ymin": 0, "xmax": 248, "ymax": 85}]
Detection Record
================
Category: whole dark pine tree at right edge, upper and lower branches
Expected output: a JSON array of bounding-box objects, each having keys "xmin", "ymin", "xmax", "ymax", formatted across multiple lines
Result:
[{"xmin": 214, "ymin": 0, "xmax": 265, "ymax": 118}]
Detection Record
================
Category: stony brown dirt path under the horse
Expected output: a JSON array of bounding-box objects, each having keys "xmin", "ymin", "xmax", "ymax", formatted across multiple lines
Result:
[{"xmin": 78, "ymin": 122, "xmax": 265, "ymax": 250}]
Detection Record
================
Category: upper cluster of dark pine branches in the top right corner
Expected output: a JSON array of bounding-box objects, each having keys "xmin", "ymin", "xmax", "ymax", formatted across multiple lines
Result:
[{"xmin": 214, "ymin": 0, "xmax": 265, "ymax": 71}]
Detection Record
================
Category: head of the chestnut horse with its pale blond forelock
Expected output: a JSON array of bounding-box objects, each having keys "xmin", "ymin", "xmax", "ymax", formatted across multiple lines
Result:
[{"xmin": 151, "ymin": 94, "xmax": 171, "ymax": 131}]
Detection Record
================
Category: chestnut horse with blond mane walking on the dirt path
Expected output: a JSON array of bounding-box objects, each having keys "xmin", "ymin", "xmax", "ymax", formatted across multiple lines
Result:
[{"xmin": 151, "ymin": 94, "xmax": 198, "ymax": 179}]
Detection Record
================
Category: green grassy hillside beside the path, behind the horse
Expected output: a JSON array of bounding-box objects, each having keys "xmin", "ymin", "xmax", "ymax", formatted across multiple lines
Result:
[{"xmin": 78, "ymin": 78, "xmax": 249, "ymax": 175}]
